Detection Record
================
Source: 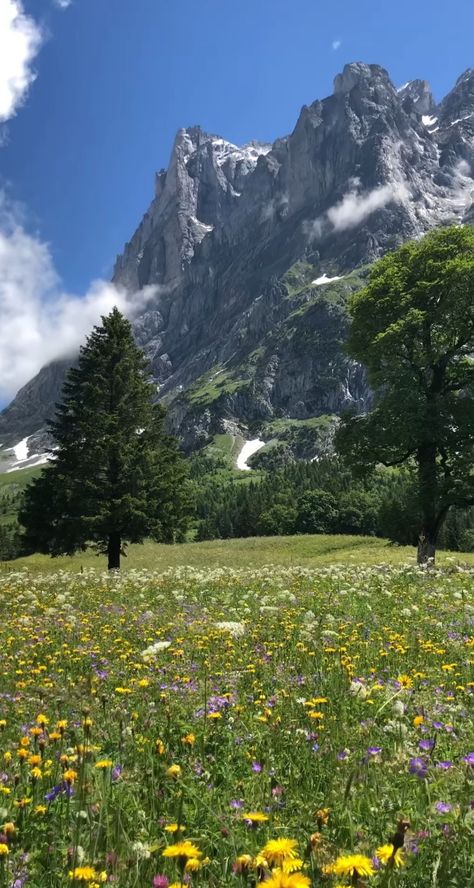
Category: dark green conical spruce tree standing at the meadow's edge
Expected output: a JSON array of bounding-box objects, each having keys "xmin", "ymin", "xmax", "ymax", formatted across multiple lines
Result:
[{"xmin": 19, "ymin": 309, "xmax": 190, "ymax": 569}]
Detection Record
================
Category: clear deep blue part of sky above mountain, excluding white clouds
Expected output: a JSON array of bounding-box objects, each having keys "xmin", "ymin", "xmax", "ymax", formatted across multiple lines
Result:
[{"xmin": 0, "ymin": 0, "xmax": 474, "ymax": 291}]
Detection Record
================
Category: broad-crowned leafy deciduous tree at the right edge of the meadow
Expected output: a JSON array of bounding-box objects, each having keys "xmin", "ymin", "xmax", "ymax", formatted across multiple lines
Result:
[{"xmin": 336, "ymin": 226, "xmax": 474, "ymax": 563}]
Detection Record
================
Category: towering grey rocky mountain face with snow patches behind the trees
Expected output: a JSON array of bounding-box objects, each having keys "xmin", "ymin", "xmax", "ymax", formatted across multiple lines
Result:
[{"xmin": 0, "ymin": 63, "xmax": 474, "ymax": 448}]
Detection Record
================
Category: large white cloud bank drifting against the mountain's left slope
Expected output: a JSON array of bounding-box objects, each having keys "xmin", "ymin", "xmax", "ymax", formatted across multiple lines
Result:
[{"xmin": 0, "ymin": 194, "xmax": 156, "ymax": 399}]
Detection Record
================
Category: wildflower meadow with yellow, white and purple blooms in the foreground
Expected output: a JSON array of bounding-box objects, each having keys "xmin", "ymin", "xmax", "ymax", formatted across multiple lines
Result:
[{"xmin": 0, "ymin": 566, "xmax": 474, "ymax": 888}]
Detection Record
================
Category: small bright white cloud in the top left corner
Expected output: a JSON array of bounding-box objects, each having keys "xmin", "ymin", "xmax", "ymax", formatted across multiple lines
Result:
[{"xmin": 0, "ymin": 0, "xmax": 43, "ymax": 123}]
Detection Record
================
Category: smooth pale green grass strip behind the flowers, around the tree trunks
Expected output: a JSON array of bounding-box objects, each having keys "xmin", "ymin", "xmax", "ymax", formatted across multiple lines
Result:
[{"xmin": 0, "ymin": 532, "xmax": 474, "ymax": 573}]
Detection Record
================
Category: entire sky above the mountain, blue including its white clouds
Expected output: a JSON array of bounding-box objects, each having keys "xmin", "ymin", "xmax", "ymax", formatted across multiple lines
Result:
[{"xmin": 0, "ymin": 0, "xmax": 474, "ymax": 398}]
